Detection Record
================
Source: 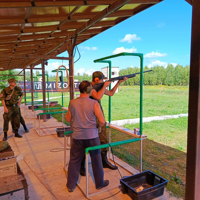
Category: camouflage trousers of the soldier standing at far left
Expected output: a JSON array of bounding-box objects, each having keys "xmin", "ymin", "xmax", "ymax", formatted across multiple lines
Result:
[{"xmin": 3, "ymin": 106, "xmax": 20, "ymax": 132}]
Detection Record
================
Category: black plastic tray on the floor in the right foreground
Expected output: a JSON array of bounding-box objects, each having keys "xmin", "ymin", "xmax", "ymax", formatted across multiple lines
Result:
[{"xmin": 120, "ymin": 170, "xmax": 168, "ymax": 200}]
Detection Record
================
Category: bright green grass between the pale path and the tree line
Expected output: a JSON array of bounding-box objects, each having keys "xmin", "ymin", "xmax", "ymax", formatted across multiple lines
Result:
[{"xmin": 23, "ymin": 86, "xmax": 188, "ymax": 120}]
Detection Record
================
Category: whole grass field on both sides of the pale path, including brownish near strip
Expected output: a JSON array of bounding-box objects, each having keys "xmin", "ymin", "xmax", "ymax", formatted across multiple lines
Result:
[{"xmin": 16, "ymin": 86, "xmax": 191, "ymax": 198}]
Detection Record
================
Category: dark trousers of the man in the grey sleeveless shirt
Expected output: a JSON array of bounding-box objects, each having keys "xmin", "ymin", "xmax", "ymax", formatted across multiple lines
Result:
[{"xmin": 67, "ymin": 138, "xmax": 104, "ymax": 189}]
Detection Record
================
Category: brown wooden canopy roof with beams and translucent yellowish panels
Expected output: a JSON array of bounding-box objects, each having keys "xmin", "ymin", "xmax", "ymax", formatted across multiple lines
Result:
[{"xmin": 0, "ymin": 0, "xmax": 168, "ymax": 71}]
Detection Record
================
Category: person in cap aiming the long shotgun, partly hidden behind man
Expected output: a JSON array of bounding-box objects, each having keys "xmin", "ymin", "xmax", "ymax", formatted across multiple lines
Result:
[{"xmin": 80, "ymin": 71, "xmax": 128, "ymax": 176}]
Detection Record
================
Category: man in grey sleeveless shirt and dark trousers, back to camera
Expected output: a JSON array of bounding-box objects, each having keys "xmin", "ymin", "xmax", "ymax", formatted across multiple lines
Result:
[{"xmin": 65, "ymin": 81, "xmax": 109, "ymax": 192}]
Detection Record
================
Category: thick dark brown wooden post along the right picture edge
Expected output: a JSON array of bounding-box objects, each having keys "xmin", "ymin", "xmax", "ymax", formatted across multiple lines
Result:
[{"xmin": 185, "ymin": 0, "xmax": 200, "ymax": 200}]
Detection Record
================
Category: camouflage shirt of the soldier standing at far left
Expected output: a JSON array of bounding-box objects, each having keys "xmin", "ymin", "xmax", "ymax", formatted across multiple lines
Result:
[{"xmin": 0, "ymin": 86, "xmax": 23, "ymax": 106}]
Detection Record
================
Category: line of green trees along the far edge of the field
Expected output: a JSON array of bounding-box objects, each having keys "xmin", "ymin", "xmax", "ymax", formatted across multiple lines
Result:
[{"xmin": 0, "ymin": 64, "xmax": 190, "ymax": 89}]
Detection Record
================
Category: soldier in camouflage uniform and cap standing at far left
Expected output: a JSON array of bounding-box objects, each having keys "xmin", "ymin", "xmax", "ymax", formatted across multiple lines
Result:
[{"xmin": 0, "ymin": 78, "xmax": 23, "ymax": 141}]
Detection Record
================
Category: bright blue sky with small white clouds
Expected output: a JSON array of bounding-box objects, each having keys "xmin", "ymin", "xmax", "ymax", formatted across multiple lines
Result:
[{"xmin": 46, "ymin": 0, "xmax": 192, "ymax": 75}]
